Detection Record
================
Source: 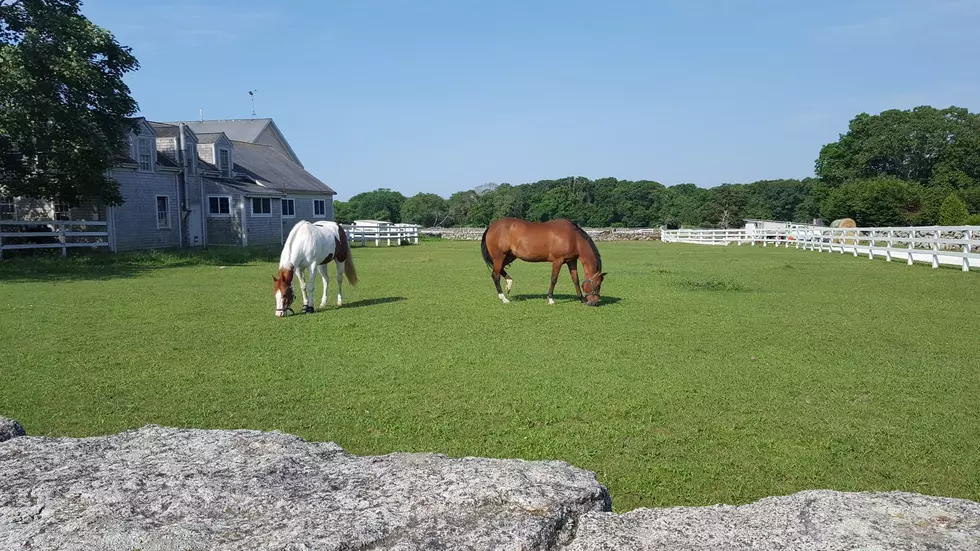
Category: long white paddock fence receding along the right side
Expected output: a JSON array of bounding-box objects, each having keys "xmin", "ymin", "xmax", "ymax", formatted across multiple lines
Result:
[{"xmin": 661, "ymin": 226, "xmax": 980, "ymax": 272}]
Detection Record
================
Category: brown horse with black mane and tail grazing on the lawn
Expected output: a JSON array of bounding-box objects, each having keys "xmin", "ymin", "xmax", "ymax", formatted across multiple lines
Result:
[{"xmin": 480, "ymin": 218, "xmax": 606, "ymax": 306}]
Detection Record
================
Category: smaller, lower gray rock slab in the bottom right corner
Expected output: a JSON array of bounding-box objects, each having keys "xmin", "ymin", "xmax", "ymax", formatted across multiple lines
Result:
[{"xmin": 567, "ymin": 490, "xmax": 980, "ymax": 551}]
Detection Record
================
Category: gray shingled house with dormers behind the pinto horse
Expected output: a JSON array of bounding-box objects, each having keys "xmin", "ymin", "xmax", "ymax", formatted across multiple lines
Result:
[{"xmin": 0, "ymin": 118, "xmax": 336, "ymax": 251}]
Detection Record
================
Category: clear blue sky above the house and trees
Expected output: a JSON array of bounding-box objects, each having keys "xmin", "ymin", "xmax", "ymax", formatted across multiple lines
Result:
[{"xmin": 82, "ymin": 0, "xmax": 980, "ymax": 199}]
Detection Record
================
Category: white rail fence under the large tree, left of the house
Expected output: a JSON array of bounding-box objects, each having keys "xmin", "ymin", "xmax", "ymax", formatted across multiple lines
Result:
[{"xmin": 0, "ymin": 220, "xmax": 112, "ymax": 259}]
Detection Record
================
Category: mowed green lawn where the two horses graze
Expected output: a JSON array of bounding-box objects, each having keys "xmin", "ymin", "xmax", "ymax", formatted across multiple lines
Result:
[{"xmin": 0, "ymin": 241, "xmax": 980, "ymax": 511}]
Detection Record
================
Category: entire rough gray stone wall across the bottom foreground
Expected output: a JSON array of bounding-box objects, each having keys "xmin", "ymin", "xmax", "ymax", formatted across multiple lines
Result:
[{"xmin": 0, "ymin": 417, "xmax": 980, "ymax": 551}]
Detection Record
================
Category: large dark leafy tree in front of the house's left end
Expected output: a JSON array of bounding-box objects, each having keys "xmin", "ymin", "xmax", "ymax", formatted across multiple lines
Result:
[{"xmin": 0, "ymin": 0, "xmax": 139, "ymax": 205}]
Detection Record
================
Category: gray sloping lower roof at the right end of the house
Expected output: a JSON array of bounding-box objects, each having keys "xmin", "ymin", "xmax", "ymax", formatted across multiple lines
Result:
[{"xmin": 232, "ymin": 140, "xmax": 337, "ymax": 195}]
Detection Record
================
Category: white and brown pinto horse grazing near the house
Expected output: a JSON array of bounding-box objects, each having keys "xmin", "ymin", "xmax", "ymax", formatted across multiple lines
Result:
[{"xmin": 272, "ymin": 220, "xmax": 357, "ymax": 317}]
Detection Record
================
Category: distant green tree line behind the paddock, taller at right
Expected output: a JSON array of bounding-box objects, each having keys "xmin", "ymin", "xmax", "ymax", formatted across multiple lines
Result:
[{"xmin": 334, "ymin": 106, "xmax": 980, "ymax": 228}]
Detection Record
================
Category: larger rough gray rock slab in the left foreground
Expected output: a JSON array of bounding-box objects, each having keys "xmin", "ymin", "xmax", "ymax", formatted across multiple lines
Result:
[{"xmin": 0, "ymin": 425, "xmax": 609, "ymax": 551}]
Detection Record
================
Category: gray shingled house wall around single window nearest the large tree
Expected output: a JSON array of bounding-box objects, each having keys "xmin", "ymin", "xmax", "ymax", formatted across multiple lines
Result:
[{"xmin": 112, "ymin": 169, "xmax": 180, "ymax": 251}]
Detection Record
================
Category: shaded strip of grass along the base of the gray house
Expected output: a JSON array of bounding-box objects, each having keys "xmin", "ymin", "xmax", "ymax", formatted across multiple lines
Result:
[{"xmin": 0, "ymin": 246, "xmax": 280, "ymax": 283}]
